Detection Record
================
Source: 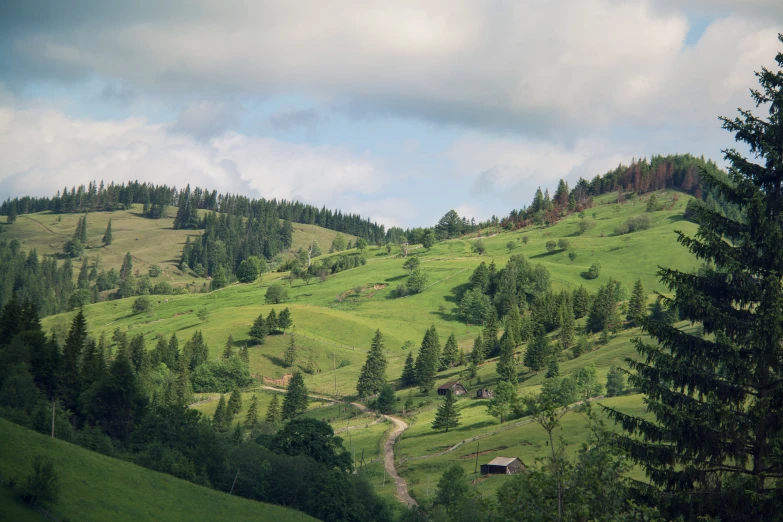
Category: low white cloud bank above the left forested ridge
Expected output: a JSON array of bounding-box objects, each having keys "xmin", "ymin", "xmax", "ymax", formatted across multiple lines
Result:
[{"xmin": 0, "ymin": 107, "xmax": 411, "ymax": 223}]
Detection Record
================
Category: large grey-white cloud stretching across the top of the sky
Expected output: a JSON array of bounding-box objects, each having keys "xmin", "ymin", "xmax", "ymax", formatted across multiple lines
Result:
[{"xmin": 7, "ymin": 0, "xmax": 783, "ymax": 135}]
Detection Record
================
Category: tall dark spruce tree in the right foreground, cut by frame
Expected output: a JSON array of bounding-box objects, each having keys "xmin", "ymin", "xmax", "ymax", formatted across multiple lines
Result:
[{"xmin": 609, "ymin": 39, "xmax": 783, "ymax": 521}]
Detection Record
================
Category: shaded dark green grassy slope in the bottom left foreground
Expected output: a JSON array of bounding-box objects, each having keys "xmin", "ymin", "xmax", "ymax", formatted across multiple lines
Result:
[{"xmin": 0, "ymin": 419, "xmax": 314, "ymax": 521}]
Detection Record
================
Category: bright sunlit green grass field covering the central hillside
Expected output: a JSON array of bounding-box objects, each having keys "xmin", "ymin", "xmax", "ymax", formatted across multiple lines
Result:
[{"xmin": 30, "ymin": 192, "xmax": 698, "ymax": 498}]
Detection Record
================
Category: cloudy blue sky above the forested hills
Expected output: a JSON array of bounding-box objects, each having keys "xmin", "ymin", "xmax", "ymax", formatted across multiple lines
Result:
[{"xmin": 0, "ymin": 0, "xmax": 783, "ymax": 227}]
